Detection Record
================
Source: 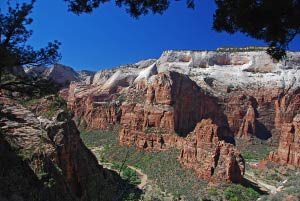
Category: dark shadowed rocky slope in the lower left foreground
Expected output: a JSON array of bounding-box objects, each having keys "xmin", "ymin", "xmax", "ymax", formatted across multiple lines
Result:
[{"xmin": 0, "ymin": 97, "xmax": 138, "ymax": 201}]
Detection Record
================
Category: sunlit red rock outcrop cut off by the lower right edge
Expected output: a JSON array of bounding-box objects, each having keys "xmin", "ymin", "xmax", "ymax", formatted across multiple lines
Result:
[{"xmin": 269, "ymin": 114, "xmax": 300, "ymax": 167}]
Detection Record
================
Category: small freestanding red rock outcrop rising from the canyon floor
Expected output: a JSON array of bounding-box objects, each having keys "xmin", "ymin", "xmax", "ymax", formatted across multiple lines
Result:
[{"xmin": 179, "ymin": 119, "xmax": 245, "ymax": 183}]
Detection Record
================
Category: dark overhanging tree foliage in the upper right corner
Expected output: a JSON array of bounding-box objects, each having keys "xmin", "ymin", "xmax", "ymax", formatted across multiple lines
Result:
[{"xmin": 213, "ymin": 0, "xmax": 300, "ymax": 59}]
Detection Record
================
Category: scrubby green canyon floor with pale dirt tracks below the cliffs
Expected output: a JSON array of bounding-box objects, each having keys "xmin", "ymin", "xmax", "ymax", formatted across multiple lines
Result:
[{"xmin": 81, "ymin": 126, "xmax": 299, "ymax": 200}]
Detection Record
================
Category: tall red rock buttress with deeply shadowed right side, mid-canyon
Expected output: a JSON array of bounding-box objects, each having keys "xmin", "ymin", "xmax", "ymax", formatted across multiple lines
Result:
[{"xmin": 119, "ymin": 72, "xmax": 233, "ymax": 149}]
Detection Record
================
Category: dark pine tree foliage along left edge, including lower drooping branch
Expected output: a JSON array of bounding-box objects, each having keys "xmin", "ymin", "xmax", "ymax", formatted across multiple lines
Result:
[{"xmin": 0, "ymin": 0, "xmax": 60, "ymax": 96}]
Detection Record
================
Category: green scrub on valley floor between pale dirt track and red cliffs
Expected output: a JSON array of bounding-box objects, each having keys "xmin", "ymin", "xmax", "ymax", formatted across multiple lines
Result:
[{"xmin": 81, "ymin": 127, "xmax": 259, "ymax": 201}]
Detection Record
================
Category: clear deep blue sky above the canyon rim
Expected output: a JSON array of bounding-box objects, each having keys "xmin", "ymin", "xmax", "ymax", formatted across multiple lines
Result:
[{"xmin": 0, "ymin": 0, "xmax": 300, "ymax": 71}]
